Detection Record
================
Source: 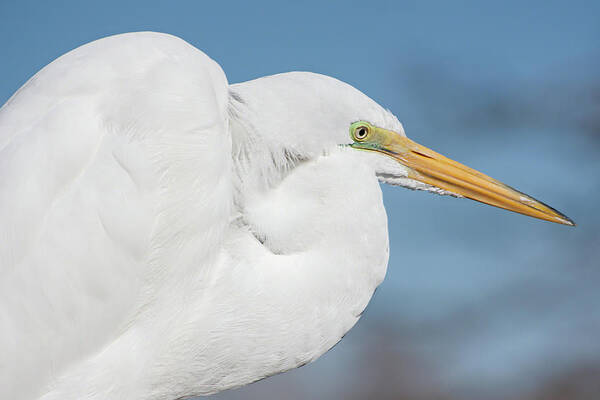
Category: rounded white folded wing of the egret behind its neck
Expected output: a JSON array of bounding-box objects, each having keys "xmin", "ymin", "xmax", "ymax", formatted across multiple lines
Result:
[{"xmin": 0, "ymin": 33, "xmax": 231, "ymax": 399}]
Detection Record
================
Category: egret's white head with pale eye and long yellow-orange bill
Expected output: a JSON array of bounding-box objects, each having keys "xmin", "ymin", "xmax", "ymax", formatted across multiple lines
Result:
[{"xmin": 234, "ymin": 72, "xmax": 575, "ymax": 225}]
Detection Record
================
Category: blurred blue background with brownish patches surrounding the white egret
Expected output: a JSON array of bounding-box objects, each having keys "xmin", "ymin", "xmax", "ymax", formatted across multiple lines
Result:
[{"xmin": 0, "ymin": 0, "xmax": 600, "ymax": 399}]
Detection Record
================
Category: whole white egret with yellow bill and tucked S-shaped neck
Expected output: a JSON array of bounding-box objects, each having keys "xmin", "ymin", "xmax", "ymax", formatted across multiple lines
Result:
[{"xmin": 0, "ymin": 33, "xmax": 573, "ymax": 400}]
